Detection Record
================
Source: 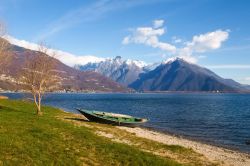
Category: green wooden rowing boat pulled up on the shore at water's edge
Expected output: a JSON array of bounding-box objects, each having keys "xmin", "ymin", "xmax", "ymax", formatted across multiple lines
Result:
[{"xmin": 76, "ymin": 109, "xmax": 148, "ymax": 126}]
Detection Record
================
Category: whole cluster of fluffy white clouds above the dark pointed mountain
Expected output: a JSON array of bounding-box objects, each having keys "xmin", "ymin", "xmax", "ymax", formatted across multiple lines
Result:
[{"xmin": 122, "ymin": 20, "xmax": 229, "ymax": 63}]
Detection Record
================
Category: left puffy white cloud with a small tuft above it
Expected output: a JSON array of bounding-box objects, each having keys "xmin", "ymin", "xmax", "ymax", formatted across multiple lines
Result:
[{"xmin": 122, "ymin": 20, "xmax": 176, "ymax": 53}]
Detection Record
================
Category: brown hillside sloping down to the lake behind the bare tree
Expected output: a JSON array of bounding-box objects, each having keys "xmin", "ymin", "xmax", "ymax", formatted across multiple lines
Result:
[{"xmin": 0, "ymin": 45, "xmax": 131, "ymax": 92}]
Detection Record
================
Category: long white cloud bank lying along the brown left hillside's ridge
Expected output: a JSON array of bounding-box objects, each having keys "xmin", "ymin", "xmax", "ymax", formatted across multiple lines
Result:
[{"xmin": 4, "ymin": 35, "xmax": 105, "ymax": 67}]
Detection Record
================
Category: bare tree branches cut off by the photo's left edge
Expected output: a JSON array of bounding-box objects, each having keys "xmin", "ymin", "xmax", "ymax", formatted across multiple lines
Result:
[{"xmin": 0, "ymin": 22, "xmax": 11, "ymax": 70}]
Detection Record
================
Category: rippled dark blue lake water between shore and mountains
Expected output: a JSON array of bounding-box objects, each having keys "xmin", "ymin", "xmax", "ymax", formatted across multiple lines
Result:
[{"xmin": 1, "ymin": 93, "xmax": 250, "ymax": 153}]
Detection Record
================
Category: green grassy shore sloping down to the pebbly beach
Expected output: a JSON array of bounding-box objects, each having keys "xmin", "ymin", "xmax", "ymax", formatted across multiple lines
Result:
[{"xmin": 0, "ymin": 100, "xmax": 215, "ymax": 165}]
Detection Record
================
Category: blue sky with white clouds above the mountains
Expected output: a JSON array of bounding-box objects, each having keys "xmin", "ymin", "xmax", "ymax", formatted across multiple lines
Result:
[{"xmin": 0, "ymin": 0, "xmax": 250, "ymax": 84}]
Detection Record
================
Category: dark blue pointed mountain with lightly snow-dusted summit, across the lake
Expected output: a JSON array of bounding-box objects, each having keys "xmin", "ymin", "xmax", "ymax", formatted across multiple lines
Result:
[{"xmin": 129, "ymin": 58, "xmax": 248, "ymax": 92}]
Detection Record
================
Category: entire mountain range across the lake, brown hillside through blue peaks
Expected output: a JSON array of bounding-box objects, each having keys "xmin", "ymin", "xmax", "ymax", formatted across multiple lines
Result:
[{"xmin": 0, "ymin": 38, "xmax": 250, "ymax": 92}]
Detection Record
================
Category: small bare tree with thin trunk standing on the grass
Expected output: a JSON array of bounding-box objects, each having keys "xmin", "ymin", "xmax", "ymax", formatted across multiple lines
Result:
[{"xmin": 20, "ymin": 44, "xmax": 58, "ymax": 115}]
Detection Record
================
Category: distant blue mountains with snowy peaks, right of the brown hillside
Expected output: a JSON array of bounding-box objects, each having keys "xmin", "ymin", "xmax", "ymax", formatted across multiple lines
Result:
[{"xmin": 77, "ymin": 57, "xmax": 249, "ymax": 92}]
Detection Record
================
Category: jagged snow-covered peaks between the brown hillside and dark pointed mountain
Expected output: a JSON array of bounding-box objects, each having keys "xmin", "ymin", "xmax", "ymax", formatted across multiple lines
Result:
[{"xmin": 75, "ymin": 56, "xmax": 147, "ymax": 86}]
